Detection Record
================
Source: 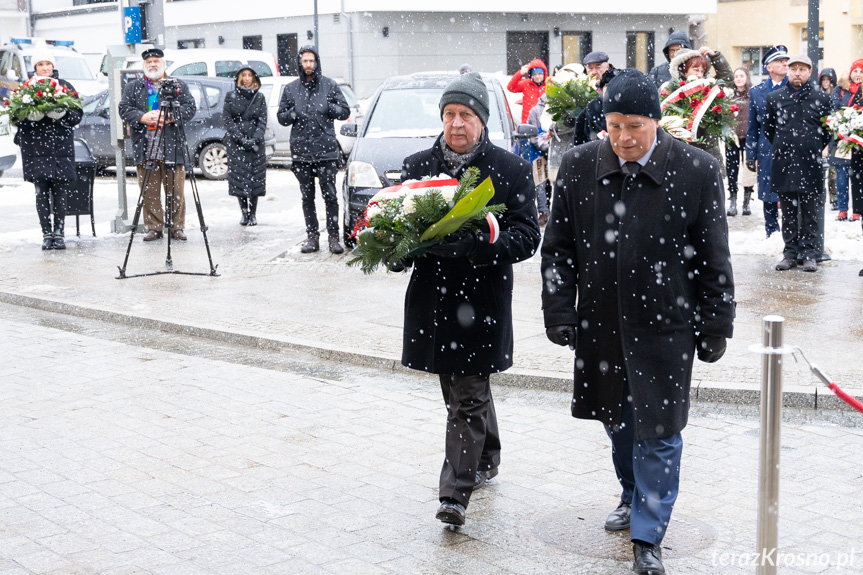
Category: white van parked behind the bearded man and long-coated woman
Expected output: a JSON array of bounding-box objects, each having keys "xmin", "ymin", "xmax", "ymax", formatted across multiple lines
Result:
[{"xmin": 102, "ymin": 48, "xmax": 279, "ymax": 78}]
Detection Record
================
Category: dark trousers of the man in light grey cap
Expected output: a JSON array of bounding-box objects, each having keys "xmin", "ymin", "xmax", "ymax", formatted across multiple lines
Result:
[{"xmin": 779, "ymin": 190, "xmax": 824, "ymax": 260}]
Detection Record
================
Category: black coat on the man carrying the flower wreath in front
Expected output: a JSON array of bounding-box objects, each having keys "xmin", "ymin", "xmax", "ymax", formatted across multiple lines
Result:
[{"xmin": 402, "ymin": 131, "xmax": 540, "ymax": 375}]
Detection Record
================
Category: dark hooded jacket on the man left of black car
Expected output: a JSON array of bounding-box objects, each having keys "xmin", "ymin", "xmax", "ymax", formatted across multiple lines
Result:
[{"xmin": 276, "ymin": 46, "xmax": 351, "ymax": 162}]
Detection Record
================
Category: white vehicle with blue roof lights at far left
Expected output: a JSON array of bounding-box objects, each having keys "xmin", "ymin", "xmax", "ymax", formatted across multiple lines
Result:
[{"xmin": 0, "ymin": 38, "xmax": 107, "ymax": 98}]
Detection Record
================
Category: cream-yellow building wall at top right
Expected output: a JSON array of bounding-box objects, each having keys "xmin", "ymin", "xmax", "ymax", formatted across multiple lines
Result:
[{"xmin": 704, "ymin": 0, "xmax": 863, "ymax": 76}]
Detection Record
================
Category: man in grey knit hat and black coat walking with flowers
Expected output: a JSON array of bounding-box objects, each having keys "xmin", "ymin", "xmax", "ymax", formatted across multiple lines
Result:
[{"xmin": 402, "ymin": 72, "xmax": 540, "ymax": 525}]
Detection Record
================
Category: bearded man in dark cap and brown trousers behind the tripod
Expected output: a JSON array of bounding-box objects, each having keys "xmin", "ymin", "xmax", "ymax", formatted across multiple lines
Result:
[{"xmin": 119, "ymin": 48, "xmax": 196, "ymax": 242}]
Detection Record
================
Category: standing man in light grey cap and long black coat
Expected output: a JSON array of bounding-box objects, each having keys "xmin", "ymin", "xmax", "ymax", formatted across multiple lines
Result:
[{"xmin": 764, "ymin": 55, "xmax": 832, "ymax": 272}]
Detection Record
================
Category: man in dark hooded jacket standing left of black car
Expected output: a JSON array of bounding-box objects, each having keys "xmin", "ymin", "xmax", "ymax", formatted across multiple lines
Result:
[{"xmin": 278, "ymin": 46, "xmax": 351, "ymax": 254}]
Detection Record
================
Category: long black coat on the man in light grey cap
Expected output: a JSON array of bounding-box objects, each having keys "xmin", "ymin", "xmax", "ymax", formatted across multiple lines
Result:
[{"xmin": 764, "ymin": 82, "xmax": 832, "ymax": 194}]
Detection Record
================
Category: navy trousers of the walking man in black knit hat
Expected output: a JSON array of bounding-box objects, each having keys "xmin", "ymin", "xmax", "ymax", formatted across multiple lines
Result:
[{"xmin": 605, "ymin": 389, "xmax": 683, "ymax": 545}]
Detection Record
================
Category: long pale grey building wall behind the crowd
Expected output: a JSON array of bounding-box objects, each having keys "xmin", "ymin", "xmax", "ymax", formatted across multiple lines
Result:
[{"xmin": 166, "ymin": 12, "xmax": 689, "ymax": 98}]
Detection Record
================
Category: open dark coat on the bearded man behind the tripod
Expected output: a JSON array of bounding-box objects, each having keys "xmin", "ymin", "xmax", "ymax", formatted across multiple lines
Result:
[{"xmin": 118, "ymin": 75, "xmax": 197, "ymax": 166}]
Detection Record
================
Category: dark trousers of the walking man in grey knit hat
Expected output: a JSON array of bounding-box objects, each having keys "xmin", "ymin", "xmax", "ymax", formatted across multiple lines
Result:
[{"xmin": 439, "ymin": 374, "xmax": 500, "ymax": 507}]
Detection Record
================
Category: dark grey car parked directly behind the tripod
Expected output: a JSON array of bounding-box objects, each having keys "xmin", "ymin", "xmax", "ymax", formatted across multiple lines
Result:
[{"xmin": 75, "ymin": 76, "xmax": 276, "ymax": 180}]
